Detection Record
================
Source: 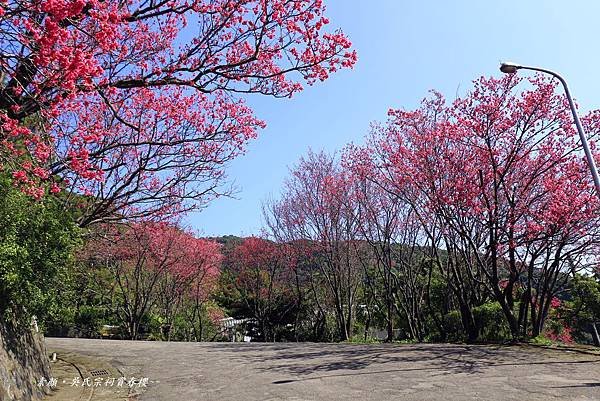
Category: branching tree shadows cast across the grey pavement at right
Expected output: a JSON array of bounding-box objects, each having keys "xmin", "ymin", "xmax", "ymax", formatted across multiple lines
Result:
[{"xmin": 202, "ymin": 343, "xmax": 600, "ymax": 378}]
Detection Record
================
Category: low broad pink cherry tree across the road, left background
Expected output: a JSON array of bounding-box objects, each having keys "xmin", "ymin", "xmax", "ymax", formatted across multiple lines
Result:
[{"xmin": 85, "ymin": 222, "xmax": 222, "ymax": 339}]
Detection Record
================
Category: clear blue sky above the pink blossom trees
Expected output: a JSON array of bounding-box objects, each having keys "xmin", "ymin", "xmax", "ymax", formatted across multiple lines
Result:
[{"xmin": 187, "ymin": 0, "xmax": 600, "ymax": 236}]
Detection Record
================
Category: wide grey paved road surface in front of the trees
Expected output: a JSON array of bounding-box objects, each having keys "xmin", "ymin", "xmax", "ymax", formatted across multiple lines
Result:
[{"xmin": 47, "ymin": 338, "xmax": 600, "ymax": 401}]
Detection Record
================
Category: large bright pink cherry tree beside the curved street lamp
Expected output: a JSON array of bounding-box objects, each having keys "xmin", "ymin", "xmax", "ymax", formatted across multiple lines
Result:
[{"xmin": 372, "ymin": 76, "xmax": 599, "ymax": 338}]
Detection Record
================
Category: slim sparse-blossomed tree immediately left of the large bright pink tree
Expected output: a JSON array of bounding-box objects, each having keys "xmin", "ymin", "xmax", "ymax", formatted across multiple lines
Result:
[{"xmin": 342, "ymin": 150, "xmax": 427, "ymax": 341}]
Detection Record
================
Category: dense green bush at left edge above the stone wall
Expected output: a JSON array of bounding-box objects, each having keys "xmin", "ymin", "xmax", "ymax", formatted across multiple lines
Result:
[{"xmin": 0, "ymin": 176, "xmax": 80, "ymax": 322}]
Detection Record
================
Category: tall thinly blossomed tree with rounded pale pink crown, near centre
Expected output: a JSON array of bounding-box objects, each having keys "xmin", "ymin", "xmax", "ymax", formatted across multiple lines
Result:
[{"xmin": 267, "ymin": 152, "xmax": 362, "ymax": 340}]
